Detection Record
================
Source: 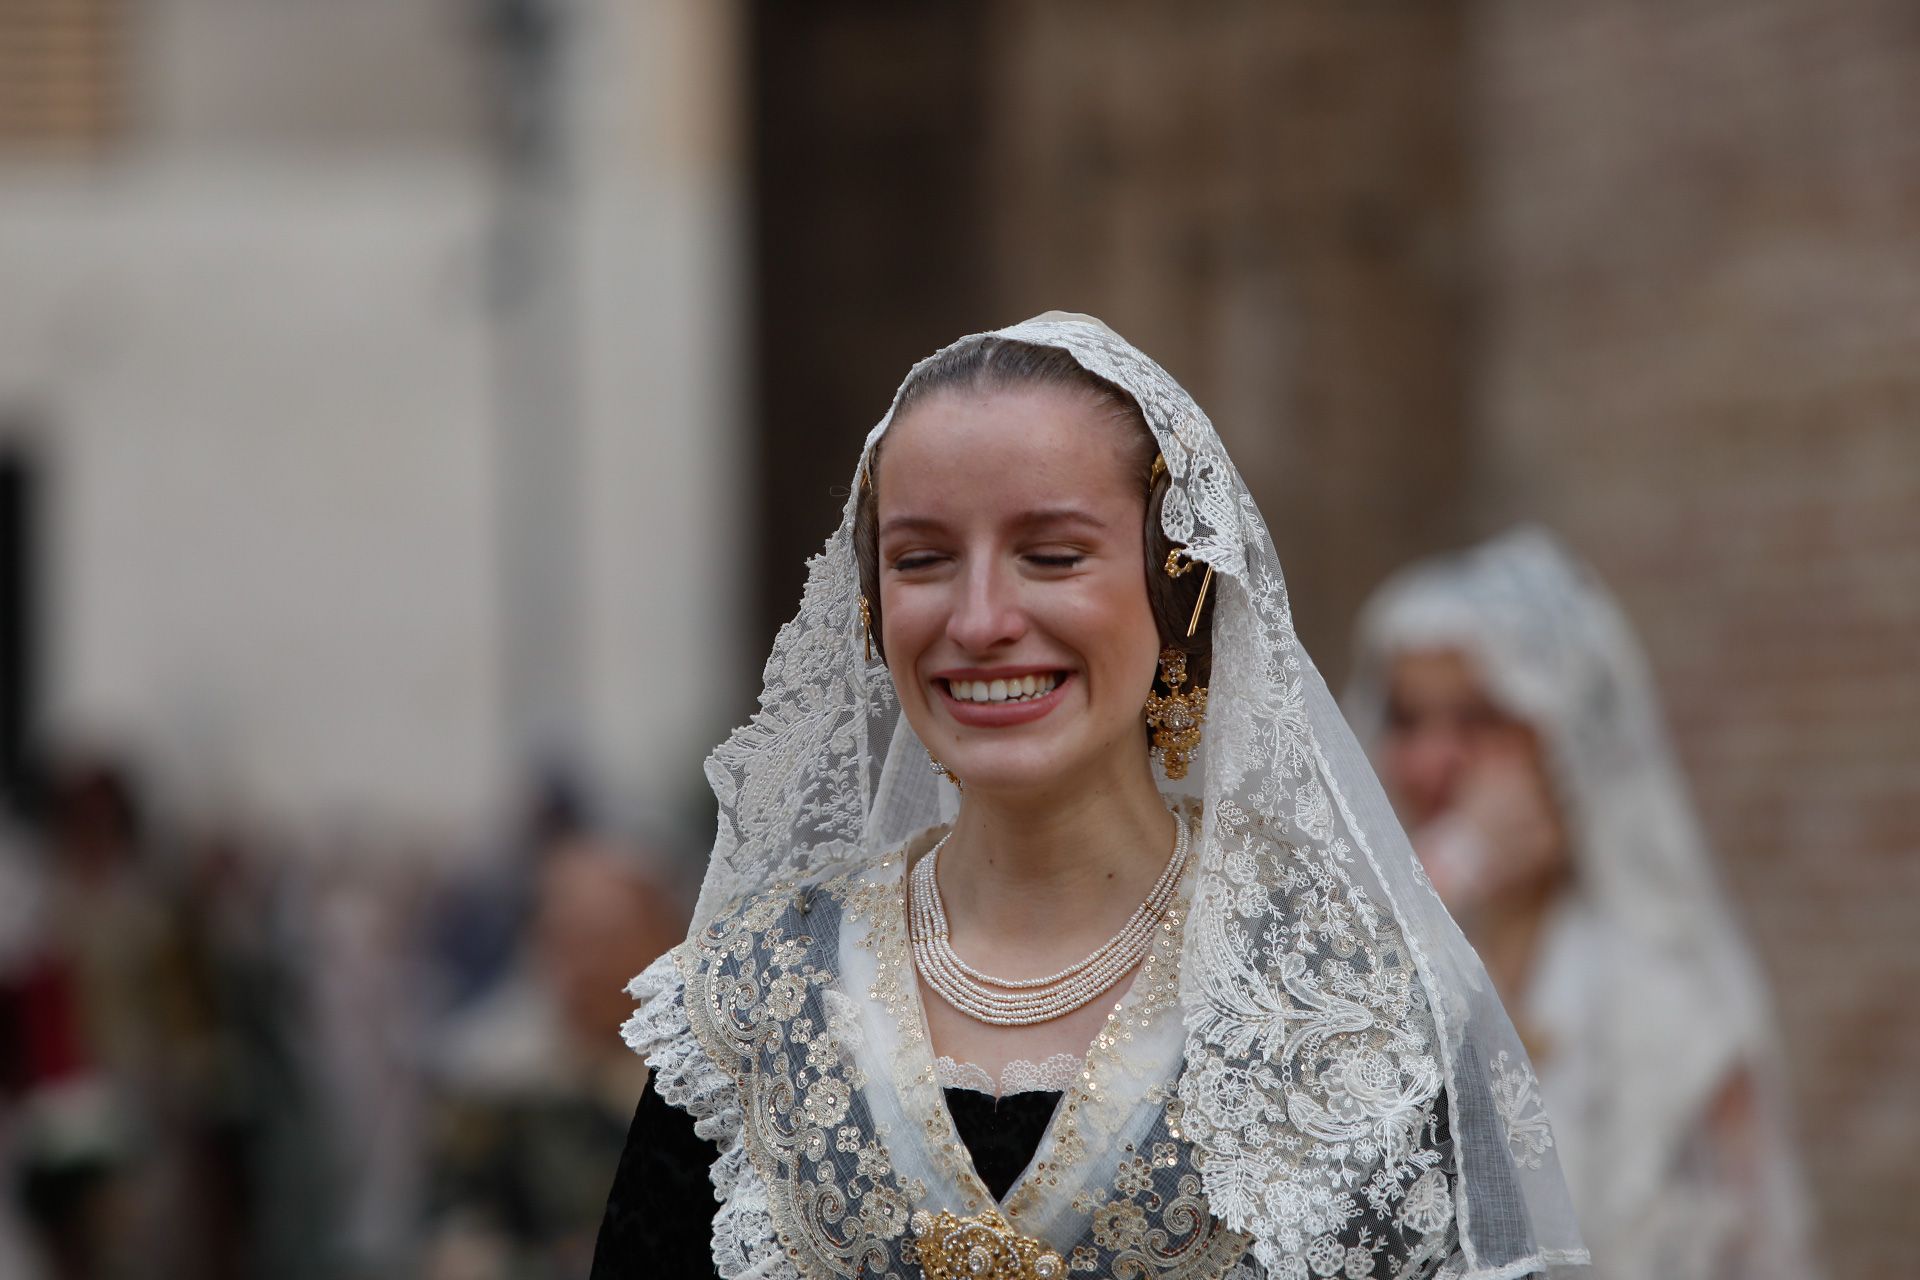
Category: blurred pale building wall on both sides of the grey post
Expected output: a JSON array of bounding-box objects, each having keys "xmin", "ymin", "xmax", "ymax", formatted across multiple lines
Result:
[{"xmin": 0, "ymin": 0, "xmax": 739, "ymax": 833}]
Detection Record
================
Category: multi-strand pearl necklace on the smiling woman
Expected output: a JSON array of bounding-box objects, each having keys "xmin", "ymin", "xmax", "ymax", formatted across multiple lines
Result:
[{"xmin": 906, "ymin": 816, "xmax": 1187, "ymax": 1027}]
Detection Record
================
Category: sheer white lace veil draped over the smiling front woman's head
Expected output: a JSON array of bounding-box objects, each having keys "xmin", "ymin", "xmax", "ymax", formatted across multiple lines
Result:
[{"xmin": 693, "ymin": 313, "xmax": 1584, "ymax": 1280}]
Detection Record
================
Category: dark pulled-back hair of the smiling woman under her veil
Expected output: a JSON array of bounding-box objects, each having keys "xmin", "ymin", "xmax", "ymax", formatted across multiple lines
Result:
[{"xmin": 852, "ymin": 336, "xmax": 1213, "ymax": 685}]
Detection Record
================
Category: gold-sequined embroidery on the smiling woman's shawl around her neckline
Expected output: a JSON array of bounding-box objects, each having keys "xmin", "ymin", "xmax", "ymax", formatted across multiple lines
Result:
[{"xmin": 680, "ymin": 860, "xmax": 1248, "ymax": 1280}]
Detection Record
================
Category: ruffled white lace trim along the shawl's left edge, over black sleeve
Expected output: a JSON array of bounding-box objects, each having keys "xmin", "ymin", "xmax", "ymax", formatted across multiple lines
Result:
[{"xmin": 620, "ymin": 952, "xmax": 799, "ymax": 1280}]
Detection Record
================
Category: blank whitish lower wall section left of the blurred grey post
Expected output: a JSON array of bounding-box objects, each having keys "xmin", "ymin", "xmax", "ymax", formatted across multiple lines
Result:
[{"xmin": 0, "ymin": 159, "xmax": 499, "ymax": 818}]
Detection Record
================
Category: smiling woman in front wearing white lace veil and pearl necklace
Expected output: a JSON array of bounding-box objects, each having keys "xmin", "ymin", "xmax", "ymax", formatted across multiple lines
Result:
[{"xmin": 595, "ymin": 313, "xmax": 1582, "ymax": 1280}]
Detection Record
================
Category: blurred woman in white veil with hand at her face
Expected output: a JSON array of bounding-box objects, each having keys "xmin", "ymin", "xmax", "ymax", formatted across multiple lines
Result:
[{"xmin": 1348, "ymin": 530, "xmax": 1814, "ymax": 1280}]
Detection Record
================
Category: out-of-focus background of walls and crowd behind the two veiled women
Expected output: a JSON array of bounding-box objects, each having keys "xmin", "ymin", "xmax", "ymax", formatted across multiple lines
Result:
[{"xmin": 0, "ymin": 0, "xmax": 1920, "ymax": 1280}]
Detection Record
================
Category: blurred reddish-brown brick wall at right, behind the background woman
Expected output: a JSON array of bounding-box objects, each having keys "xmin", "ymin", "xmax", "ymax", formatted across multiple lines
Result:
[{"xmin": 1469, "ymin": 0, "xmax": 1920, "ymax": 1276}]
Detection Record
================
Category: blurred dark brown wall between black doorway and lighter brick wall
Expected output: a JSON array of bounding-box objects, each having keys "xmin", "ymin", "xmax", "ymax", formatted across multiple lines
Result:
[{"xmin": 985, "ymin": 0, "xmax": 1469, "ymax": 676}]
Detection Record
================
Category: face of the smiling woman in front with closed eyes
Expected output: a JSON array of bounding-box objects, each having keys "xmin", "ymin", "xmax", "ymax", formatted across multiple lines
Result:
[{"xmin": 874, "ymin": 386, "xmax": 1160, "ymax": 793}]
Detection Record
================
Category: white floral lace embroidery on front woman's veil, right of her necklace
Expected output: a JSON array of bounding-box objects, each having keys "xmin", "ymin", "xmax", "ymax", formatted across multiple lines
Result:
[{"xmin": 1181, "ymin": 821, "xmax": 1452, "ymax": 1276}]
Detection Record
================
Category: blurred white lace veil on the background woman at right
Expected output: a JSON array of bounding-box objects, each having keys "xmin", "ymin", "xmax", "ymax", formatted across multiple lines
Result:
[{"xmin": 1346, "ymin": 528, "xmax": 1816, "ymax": 1276}]
